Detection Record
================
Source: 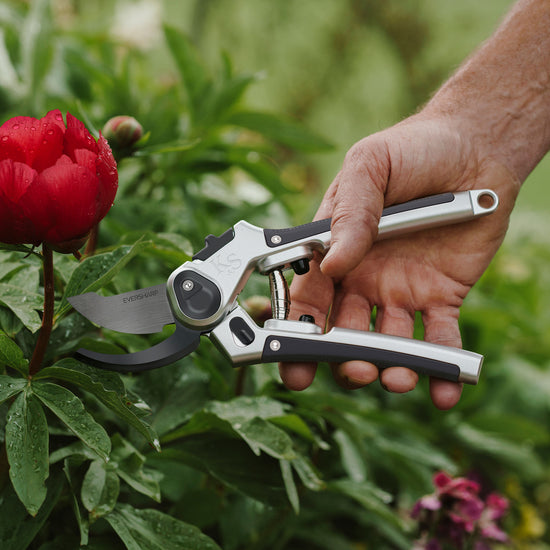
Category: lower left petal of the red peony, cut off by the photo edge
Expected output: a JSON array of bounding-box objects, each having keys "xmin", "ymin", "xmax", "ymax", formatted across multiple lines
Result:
[{"xmin": 0, "ymin": 160, "xmax": 42, "ymax": 245}]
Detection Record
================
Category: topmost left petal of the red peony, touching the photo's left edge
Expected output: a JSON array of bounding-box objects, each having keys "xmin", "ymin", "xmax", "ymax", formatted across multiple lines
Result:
[{"xmin": 0, "ymin": 114, "xmax": 63, "ymax": 172}]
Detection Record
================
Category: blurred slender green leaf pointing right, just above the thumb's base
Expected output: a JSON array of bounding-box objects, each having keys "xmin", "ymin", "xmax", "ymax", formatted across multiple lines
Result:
[{"xmin": 227, "ymin": 111, "xmax": 333, "ymax": 153}]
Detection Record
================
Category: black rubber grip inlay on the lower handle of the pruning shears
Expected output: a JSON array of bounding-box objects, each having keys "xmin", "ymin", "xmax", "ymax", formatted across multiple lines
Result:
[{"xmin": 262, "ymin": 336, "xmax": 460, "ymax": 382}]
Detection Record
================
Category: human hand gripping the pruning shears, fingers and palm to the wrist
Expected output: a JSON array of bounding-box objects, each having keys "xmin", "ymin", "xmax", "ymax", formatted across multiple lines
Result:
[{"xmin": 280, "ymin": 113, "xmax": 520, "ymax": 409}]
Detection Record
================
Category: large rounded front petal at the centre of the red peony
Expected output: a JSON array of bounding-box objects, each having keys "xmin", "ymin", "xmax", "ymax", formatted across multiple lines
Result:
[{"xmin": 23, "ymin": 163, "xmax": 99, "ymax": 244}]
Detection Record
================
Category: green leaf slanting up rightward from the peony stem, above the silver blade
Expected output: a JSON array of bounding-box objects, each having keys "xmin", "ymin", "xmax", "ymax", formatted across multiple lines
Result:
[{"xmin": 56, "ymin": 241, "xmax": 151, "ymax": 316}]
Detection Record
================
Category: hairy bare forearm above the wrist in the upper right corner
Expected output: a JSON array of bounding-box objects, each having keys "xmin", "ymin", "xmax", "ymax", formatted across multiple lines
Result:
[{"xmin": 423, "ymin": 0, "xmax": 550, "ymax": 182}]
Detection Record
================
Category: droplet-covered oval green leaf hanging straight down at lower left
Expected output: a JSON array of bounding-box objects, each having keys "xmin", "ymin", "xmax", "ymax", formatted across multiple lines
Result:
[{"xmin": 6, "ymin": 392, "xmax": 49, "ymax": 516}]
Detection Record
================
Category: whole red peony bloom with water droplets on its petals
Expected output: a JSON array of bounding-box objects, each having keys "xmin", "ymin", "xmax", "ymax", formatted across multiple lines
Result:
[{"xmin": 0, "ymin": 110, "xmax": 118, "ymax": 250}]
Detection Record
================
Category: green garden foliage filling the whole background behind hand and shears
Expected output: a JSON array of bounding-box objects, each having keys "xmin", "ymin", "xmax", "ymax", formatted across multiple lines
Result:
[{"xmin": 0, "ymin": 0, "xmax": 550, "ymax": 550}]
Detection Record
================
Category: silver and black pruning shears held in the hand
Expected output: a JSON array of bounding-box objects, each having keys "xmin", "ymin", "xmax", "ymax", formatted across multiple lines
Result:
[{"xmin": 69, "ymin": 189, "xmax": 498, "ymax": 384}]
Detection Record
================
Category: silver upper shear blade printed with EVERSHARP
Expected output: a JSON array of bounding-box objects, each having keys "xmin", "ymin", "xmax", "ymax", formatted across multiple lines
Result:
[{"xmin": 68, "ymin": 284, "xmax": 174, "ymax": 334}]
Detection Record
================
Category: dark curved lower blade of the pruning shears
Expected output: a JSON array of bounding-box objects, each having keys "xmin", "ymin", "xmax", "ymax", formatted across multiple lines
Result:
[{"xmin": 76, "ymin": 322, "xmax": 200, "ymax": 372}]
